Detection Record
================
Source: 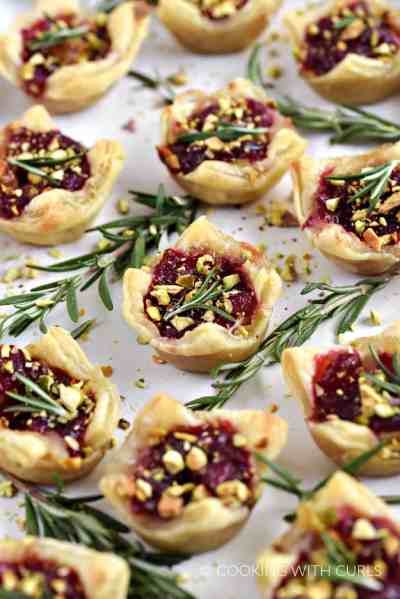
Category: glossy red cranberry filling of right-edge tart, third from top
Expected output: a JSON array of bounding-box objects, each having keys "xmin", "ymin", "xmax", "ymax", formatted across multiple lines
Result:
[{"xmin": 311, "ymin": 349, "xmax": 400, "ymax": 434}]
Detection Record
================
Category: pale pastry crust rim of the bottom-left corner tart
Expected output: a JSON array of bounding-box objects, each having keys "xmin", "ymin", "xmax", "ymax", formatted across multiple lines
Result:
[{"xmin": 0, "ymin": 537, "xmax": 129, "ymax": 599}]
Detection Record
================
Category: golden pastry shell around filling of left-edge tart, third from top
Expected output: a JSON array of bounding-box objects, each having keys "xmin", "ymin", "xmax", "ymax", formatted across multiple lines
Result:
[{"xmin": 0, "ymin": 327, "xmax": 120, "ymax": 484}]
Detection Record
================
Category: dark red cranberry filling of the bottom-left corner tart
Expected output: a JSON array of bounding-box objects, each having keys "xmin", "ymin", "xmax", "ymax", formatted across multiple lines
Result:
[{"xmin": 0, "ymin": 555, "xmax": 86, "ymax": 599}]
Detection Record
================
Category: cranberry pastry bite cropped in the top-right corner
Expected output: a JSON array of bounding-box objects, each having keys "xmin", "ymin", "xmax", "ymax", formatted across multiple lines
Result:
[{"xmin": 286, "ymin": 0, "xmax": 400, "ymax": 105}]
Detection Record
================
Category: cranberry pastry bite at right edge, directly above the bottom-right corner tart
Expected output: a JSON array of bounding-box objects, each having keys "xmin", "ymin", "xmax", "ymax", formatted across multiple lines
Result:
[{"xmin": 282, "ymin": 320, "xmax": 400, "ymax": 476}]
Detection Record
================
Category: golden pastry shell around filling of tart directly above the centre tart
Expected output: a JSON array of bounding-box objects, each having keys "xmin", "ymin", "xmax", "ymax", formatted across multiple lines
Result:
[{"xmin": 161, "ymin": 79, "xmax": 307, "ymax": 205}]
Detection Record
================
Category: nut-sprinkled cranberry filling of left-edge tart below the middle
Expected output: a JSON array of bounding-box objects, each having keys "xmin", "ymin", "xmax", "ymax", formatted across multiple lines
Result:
[{"xmin": 0, "ymin": 345, "xmax": 95, "ymax": 457}]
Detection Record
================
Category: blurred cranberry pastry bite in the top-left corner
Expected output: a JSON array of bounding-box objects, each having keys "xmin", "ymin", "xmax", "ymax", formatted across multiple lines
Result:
[{"xmin": 0, "ymin": 0, "xmax": 149, "ymax": 113}]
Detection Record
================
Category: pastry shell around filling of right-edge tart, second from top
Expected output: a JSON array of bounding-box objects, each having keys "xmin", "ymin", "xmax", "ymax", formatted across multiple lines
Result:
[{"xmin": 292, "ymin": 142, "xmax": 400, "ymax": 276}]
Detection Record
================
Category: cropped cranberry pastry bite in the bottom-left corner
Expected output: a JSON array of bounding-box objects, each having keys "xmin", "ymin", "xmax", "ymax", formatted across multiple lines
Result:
[{"xmin": 0, "ymin": 537, "xmax": 129, "ymax": 599}]
